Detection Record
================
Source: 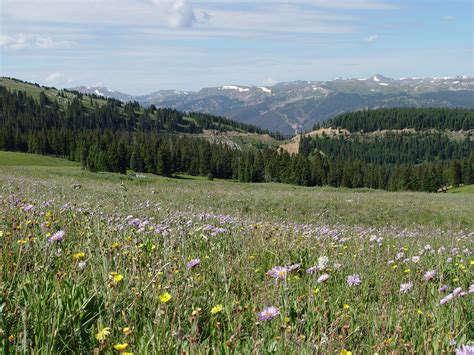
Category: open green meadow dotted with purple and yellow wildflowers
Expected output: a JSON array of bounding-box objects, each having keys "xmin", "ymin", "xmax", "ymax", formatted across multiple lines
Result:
[{"xmin": 0, "ymin": 152, "xmax": 474, "ymax": 354}]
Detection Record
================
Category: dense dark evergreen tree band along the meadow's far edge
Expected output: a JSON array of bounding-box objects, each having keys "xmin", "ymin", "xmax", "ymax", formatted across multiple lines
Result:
[{"xmin": 0, "ymin": 88, "xmax": 474, "ymax": 191}]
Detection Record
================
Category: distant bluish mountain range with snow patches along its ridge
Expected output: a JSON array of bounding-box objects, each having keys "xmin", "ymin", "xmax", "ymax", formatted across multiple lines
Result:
[{"xmin": 72, "ymin": 74, "xmax": 474, "ymax": 134}]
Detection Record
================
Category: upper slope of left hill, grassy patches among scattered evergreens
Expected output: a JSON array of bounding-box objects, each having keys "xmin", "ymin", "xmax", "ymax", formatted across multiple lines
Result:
[{"xmin": 0, "ymin": 77, "xmax": 281, "ymax": 150}]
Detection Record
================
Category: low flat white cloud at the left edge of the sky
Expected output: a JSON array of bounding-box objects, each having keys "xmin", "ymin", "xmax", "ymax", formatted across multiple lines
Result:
[{"xmin": 0, "ymin": 33, "xmax": 71, "ymax": 50}]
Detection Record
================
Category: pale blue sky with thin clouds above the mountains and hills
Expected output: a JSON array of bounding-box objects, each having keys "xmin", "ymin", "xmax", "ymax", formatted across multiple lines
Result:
[{"xmin": 0, "ymin": 0, "xmax": 474, "ymax": 94}]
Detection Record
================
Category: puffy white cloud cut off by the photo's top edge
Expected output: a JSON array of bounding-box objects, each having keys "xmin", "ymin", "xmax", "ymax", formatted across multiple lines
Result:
[{"xmin": 152, "ymin": 0, "xmax": 196, "ymax": 28}]
